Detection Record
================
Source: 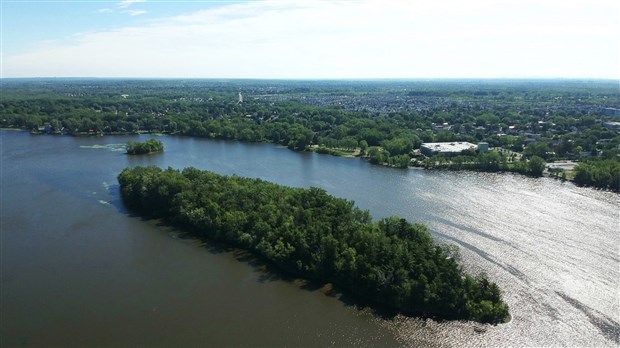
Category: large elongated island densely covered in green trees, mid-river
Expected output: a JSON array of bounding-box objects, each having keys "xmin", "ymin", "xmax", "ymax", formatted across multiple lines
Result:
[{"xmin": 118, "ymin": 167, "xmax": 509, "ymax": 323}]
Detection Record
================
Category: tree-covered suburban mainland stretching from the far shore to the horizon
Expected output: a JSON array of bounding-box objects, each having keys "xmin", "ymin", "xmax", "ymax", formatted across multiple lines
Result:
[{"xmin": 0, "ymin": 79, "xmax": 620, "ymax": 191}]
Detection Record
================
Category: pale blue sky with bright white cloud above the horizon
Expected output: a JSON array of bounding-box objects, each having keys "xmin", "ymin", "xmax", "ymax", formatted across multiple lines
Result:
[{"xmin": 0, "ymin": 0, "xmax": 620, "ymax": 79}]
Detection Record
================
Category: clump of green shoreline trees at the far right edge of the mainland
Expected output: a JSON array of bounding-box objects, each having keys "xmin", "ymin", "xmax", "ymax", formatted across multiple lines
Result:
[{"xmin": 573, "ymin": 158, "xmax": 620, "ymax": 192}]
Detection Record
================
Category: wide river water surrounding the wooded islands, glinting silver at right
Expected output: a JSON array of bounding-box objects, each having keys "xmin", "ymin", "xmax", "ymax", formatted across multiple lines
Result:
[{"xmin": 0, "ymin": 131, "xmax": 620, "ymax": 347}]
